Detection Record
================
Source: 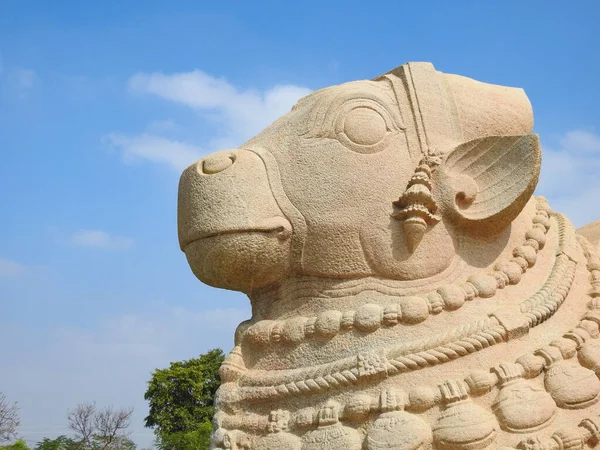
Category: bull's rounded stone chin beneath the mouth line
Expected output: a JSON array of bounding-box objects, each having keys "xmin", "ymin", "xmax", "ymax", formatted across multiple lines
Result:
[{"xmin": 185, "ymin": 232, "xmax": 291, "ymax": 293}]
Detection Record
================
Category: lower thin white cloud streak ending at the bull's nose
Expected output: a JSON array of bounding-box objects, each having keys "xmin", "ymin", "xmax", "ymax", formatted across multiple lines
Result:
[{"xmin": 107, "ymin": 133, "xmax": 203, "ymax": 171}]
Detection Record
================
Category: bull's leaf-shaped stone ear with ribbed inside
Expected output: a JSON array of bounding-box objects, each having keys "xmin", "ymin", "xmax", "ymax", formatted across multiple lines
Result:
[{"xmin": 436, "ymin": 134, "xmax": 541, "ymax": 234}]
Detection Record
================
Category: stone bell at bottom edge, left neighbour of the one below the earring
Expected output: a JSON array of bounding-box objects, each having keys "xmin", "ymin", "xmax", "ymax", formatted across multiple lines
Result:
[{"xmin": 302, "ymin": 401, "xmax": 362, "ymax": 450}]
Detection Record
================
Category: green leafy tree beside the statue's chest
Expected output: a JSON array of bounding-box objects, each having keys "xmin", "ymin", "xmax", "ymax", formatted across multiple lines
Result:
[{"xmin": 144, "ymin": 349, "xmax": 225, "ymax": 450}]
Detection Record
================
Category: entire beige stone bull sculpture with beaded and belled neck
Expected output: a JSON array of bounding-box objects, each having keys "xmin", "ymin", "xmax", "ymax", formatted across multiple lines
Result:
[{"xmin": 179, "ymin": 63, "xmax": 600, "ymax": 450}]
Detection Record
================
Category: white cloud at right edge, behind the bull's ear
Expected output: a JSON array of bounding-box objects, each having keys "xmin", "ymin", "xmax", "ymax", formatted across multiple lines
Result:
[{"xmin": 537, "ymin": 130, "xmax": 600, "ymax": 227}]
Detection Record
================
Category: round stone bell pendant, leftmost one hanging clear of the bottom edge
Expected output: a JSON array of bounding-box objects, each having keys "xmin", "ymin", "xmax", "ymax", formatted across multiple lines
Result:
[{"xmin": 492, "ymin": 364, "xmax": 556, "ymax": 433}]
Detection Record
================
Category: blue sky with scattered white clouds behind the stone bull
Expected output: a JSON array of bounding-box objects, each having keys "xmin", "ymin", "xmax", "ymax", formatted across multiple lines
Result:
[{"xmin": 0, "ymin": 0, "xmax": 600, "ymax": 446}]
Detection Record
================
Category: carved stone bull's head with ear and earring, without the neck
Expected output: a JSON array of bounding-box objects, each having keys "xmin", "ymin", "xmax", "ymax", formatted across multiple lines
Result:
[{"xmin": 178, "ymin": 63, "xmax": 541, "ymax": 293}]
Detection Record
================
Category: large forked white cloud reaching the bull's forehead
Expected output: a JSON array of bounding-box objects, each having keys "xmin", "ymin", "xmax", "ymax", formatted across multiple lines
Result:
[{"xmin": 108, "ymin": 70, "xmax": 310, "ymax": 170}]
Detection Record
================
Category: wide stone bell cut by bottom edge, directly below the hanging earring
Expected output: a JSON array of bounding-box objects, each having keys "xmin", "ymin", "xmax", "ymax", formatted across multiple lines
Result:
[{"xmin": 366, "ymin": 389, "xmax": 433, "ymax": 450}]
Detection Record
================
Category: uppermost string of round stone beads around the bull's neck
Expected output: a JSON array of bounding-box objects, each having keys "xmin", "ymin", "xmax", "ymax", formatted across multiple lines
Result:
[{"xmin": 241, "ymin": 197, "xmax": 552, "ymax": 346}]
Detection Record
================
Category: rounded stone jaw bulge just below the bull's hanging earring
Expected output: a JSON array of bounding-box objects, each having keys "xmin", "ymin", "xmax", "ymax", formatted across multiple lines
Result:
[{"xmin": 360, "ymin": 219, "xmax": 456, "ymax": 280}]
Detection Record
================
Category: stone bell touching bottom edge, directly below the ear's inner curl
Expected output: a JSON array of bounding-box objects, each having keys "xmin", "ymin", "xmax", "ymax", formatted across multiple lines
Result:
[{"xmin": 433, "ymin": 380, "xmax": 498, "ymax": 450}]
